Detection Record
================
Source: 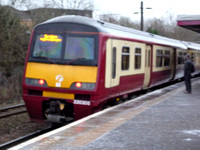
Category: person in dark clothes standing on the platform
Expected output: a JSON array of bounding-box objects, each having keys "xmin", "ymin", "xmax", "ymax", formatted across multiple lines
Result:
[{"xmin": 184, "ymin": 54, "xmax": 194, "ymax": 94}]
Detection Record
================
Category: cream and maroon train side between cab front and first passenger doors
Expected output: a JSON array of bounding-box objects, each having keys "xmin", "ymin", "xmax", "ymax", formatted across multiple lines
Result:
[{"xmin": 105, "ymin": 39, "xmax": 145, "ymax": 97}]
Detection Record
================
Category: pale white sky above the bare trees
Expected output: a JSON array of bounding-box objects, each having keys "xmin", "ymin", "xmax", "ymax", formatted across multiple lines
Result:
[{"xmin": 95, "ymin": 0, "xmax": 200, "ymax": 20}]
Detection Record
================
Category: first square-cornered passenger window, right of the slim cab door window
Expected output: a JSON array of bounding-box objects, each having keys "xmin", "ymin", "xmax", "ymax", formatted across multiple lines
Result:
[{"xmin": 121, "ymin": 47, "xmax": 130, "ymax": 70}]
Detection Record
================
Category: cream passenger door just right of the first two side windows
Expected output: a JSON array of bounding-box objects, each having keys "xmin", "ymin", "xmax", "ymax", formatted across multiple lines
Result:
[{"xmin": 143, "ymin": 45, "xmax": 151, "ymax": 89}]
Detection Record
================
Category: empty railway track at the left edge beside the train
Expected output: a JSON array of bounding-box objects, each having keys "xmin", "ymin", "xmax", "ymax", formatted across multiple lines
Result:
[{"xmin": 0, "ymin": 104, "xmax": 27, "ymax": 119}]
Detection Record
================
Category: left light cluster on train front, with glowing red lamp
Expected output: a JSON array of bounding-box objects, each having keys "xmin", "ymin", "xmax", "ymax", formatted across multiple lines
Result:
[{"xmin": 25, "ymin": 78, "xmax": 47, "ymax": 87}]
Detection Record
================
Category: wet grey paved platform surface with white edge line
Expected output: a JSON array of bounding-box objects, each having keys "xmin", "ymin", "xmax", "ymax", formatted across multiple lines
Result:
[{"xmin": 11, "ymin": 78, "xmax": 200, "ymax": 150}]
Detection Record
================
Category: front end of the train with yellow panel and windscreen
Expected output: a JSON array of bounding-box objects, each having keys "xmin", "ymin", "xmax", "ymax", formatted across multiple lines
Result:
[{"xmin": 23, "ymin": 23, "xmax": 98, "ymax": 122}]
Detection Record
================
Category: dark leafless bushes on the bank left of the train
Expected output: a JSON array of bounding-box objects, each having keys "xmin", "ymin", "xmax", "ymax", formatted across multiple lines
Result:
[{"xmin": 0, "ymin": 6, "xmax": 29, "ymax": 104}]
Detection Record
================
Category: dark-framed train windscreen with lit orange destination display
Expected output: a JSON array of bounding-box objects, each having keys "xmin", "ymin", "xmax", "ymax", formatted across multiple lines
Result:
[{"xmin": 29, "ymin": 33, "xmax": 97, "ymax": 66}]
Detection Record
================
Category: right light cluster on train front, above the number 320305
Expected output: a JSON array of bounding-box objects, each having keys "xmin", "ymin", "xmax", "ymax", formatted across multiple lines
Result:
[{"xmin": 70, "ymin": 82, "xmax": 96, "ymax": 90}]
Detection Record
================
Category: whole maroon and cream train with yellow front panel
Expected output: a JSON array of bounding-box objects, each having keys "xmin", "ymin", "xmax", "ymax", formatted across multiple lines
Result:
[{"xmin": 23, "ymin": 15, "xmax": 200, "ymax": 123}]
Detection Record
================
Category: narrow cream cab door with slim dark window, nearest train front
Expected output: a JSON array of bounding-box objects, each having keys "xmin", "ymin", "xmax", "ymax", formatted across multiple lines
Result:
[{"xmin": 105, "ymin": 39, "xmax": 119, "ymax": 88}]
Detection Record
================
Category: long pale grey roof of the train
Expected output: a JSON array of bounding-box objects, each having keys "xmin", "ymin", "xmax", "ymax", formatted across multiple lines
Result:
[{"xmin": 42, "ymin": 15, "xmax": 200, "ymax": 49}]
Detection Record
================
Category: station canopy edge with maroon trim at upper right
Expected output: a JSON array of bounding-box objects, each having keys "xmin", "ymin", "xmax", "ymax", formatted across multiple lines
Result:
[{"xmin": 177, "ymin": 15, "xmax": 200, "ymax": 33}]
